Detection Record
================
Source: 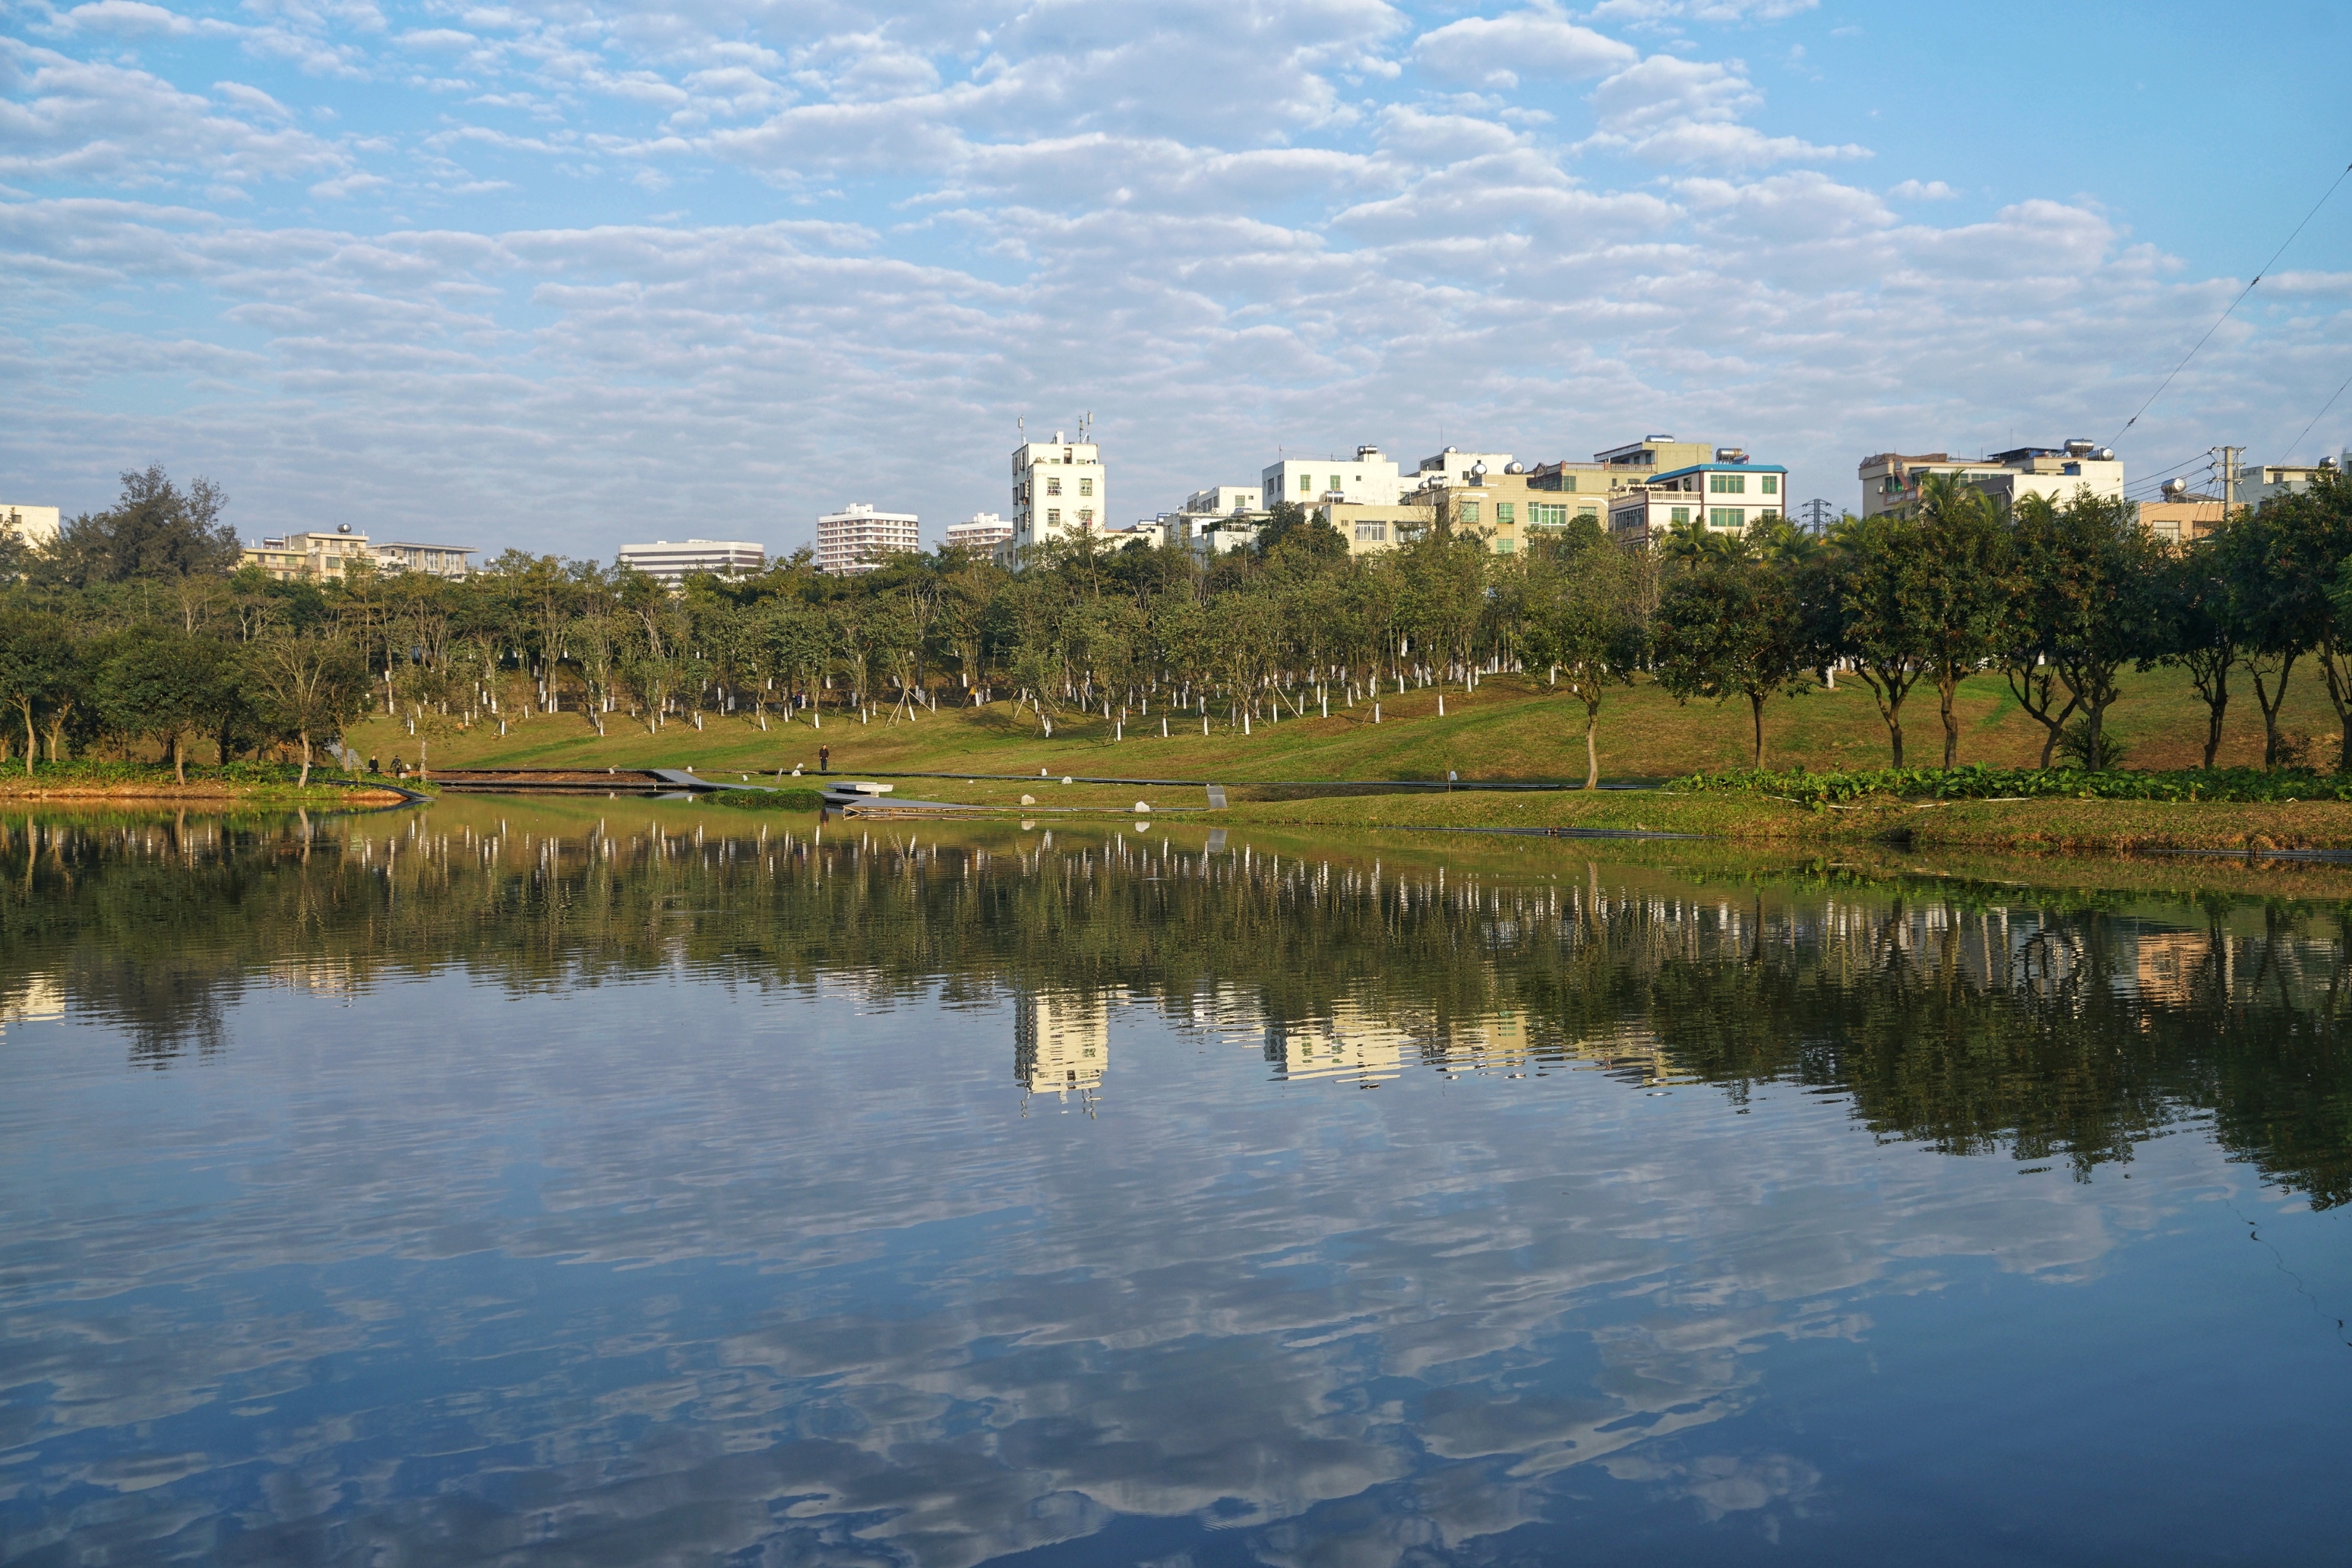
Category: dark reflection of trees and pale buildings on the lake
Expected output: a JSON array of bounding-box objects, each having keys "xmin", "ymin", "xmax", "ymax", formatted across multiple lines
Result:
[{"xmin": 0, "ymin": 801, "xmax": 2352, "ymax": 1206}]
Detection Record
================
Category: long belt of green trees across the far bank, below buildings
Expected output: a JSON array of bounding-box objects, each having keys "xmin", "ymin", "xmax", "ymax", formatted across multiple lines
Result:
[{"xmin": 14, "ymin": 470, "xmax": 2352, "ymax": 783}]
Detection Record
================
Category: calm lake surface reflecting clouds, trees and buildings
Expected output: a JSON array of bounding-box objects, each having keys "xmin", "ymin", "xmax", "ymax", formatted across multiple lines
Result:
[{"xmin": 0, "ymin": 799, "xmax": 2352, "ymax": 1568}]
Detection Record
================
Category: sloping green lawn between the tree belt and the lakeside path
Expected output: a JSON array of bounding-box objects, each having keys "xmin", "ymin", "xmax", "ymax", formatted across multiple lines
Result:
[{"xmin": 351, "ymin": 670, "xmax": 2335, "ymax": 783}]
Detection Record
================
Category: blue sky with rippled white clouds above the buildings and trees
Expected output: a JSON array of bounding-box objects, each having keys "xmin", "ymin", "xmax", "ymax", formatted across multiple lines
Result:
[{"xmin": 0, "ymin": 0, "xmax": 2352, "ymax": 557}]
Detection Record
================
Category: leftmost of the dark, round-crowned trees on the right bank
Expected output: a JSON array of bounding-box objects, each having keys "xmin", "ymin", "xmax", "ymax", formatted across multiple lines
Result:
[{"xmin": 1656, "ymin": 557, "xmax": 1809, "ymax": 769}]
